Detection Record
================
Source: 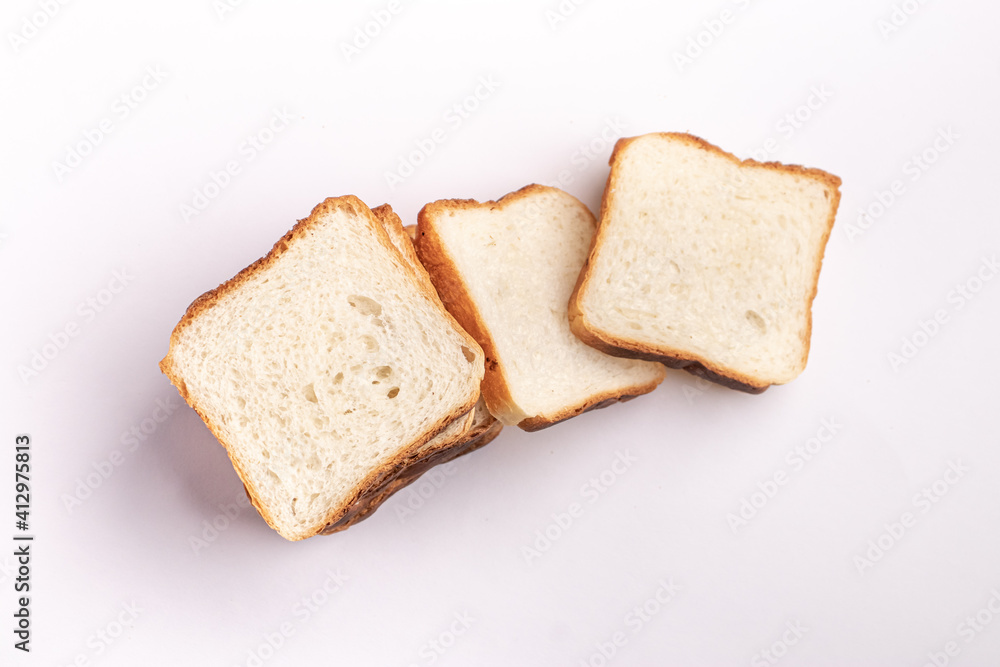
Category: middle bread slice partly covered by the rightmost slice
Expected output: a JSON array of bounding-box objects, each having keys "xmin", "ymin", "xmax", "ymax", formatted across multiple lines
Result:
[{"xmin": 415, "ymin": 185, "xmax": 665, "ymax": 431}]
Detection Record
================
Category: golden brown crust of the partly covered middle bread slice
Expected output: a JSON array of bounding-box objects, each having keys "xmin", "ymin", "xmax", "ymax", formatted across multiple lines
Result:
[{"xmin": 415, "ymin": 184, "xmax": 663, "ymax": 431}]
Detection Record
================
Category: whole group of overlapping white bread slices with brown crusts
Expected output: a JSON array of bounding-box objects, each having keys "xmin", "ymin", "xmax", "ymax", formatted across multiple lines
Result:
[{"xmin": 160, "ymin": 133, "xmax": 840, "ymax": 540}]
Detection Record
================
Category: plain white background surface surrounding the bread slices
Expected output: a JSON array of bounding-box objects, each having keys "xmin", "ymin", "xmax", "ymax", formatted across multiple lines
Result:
[{"xmin": 0, "ymin": 0, "xmax": 1000, "ymax": 666}]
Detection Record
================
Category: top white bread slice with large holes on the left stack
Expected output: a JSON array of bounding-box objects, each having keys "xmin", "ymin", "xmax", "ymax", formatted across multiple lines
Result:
[{"xmin": 160, "ymin": 196, "xmax": 483, "ymax": 540}]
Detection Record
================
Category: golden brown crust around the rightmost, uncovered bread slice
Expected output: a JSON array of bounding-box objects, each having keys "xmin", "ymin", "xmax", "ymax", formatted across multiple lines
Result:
[{"xmin": 569, "ymin": 132, "xmax": 841, "ymax": 394}]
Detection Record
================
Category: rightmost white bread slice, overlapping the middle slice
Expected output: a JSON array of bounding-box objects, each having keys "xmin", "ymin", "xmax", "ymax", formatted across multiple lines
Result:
[{"xmin": 569, "ymin": 133, "xmax": 840, "ymax": 393}]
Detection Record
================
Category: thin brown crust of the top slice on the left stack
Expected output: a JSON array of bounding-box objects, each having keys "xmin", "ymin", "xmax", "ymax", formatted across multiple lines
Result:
[{"xmin": 160, "ymin": 195, "xmax": 478, "ymax": 541}]
